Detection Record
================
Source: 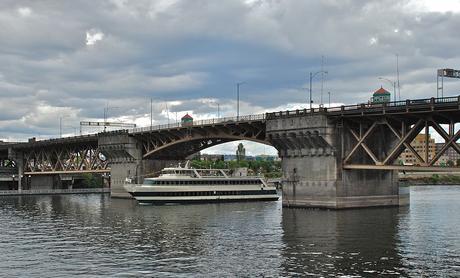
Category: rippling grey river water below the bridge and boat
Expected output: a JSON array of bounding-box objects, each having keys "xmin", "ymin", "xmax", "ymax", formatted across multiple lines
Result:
[{"xmin": 0, "ymin": 186, "xmax": 460, "ymax": 277}]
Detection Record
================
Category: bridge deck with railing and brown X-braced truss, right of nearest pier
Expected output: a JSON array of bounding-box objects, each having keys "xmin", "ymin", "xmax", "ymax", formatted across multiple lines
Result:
[{"xmin": 337, "ymin": 97, "xmax": 460, "ymax": 171}]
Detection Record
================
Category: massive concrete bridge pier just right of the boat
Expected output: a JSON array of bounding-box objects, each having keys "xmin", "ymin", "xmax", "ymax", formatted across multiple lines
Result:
[{"xmin": 267, "ymin": 114, "xmax": 406, "ymax": 209}]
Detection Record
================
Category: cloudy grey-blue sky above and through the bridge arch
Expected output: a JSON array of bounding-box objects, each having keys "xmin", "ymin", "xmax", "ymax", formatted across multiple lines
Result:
[{"xmin": 0, "ymin": 0, "xmax": 460, "ymax": 153}]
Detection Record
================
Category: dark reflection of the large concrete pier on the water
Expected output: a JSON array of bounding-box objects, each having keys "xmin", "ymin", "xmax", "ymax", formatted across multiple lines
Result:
[{"xmin": 283, "ymin": 205, "xmax": 408, "ymax": 276}]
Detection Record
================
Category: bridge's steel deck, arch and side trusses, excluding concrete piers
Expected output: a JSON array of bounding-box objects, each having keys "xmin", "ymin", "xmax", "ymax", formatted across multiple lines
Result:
[{"xmin": 0, "ymin": 94, "xmax": 460, "ymax": 175}]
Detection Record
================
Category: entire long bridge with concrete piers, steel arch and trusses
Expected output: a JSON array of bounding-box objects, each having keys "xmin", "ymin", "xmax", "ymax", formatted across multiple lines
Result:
[{"xmin": 0, "ymin": 97, "xmax": 460, "ymax": 208}]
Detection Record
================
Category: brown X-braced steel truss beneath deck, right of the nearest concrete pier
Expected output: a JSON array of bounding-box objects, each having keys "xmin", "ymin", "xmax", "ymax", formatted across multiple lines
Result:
[{"xmin": 340, "ymin": 113, "xmax": 460, "ymax": 171}]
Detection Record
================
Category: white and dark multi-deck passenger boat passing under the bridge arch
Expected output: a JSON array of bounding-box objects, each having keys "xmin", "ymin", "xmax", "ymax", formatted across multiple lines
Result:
[{"xmin": 124, "ymin": 163, "xmax": 279, "ymax": 204}]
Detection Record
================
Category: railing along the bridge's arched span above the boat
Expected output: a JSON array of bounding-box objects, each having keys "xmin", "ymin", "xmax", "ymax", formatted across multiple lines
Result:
[{"xmin": 129, "ymin": 114, "xmax": 265, "ymax": 133}]
